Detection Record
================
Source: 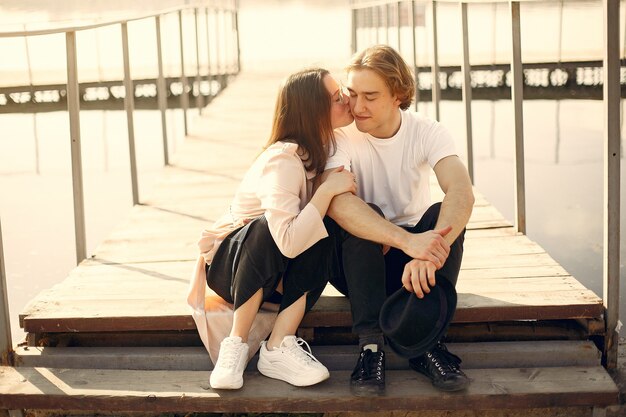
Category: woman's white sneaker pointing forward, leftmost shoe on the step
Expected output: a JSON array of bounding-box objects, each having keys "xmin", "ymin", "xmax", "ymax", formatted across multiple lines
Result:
[{"xmin": 209, "ymin": 336, "xmax": 248, "ymax": 389}]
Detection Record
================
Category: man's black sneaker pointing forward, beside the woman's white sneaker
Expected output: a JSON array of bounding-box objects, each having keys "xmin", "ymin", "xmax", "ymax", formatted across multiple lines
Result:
[{"xmin": 350, "ymin": 349, "xmax": 385, "ymax": 396}]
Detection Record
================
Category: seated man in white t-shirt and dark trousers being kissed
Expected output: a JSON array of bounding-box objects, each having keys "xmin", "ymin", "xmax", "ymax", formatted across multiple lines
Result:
[{"xmin": 326, "ymin": 45, "xmax": 474, "ymax": 395}]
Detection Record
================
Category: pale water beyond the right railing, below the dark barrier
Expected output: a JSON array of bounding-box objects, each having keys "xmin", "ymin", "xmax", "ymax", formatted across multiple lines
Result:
[{"xmin": 442, "ymin": 100, "xmax": 626, "ymax": 312}]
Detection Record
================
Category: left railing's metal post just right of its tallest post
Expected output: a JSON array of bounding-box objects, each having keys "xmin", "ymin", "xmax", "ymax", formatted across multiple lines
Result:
[{"xmin": 122, "ymin": 22, "xmax": 139, "ymax": 205}]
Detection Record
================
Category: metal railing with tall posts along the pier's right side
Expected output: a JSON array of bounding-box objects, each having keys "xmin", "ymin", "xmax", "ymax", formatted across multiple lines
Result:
[{"xmin": 351, "ymin": 0, "xmax": 621, "ymax": 368}]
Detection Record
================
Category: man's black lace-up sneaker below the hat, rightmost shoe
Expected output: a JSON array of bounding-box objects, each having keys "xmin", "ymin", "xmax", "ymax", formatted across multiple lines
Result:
[{"xmin": 409, "ymin": 342, "xmax": 469, "ymax": 391}]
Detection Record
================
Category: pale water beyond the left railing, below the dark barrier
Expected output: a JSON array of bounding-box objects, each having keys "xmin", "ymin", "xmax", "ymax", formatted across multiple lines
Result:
[{"xmin": 0, "ymin": 110, "xmax": 183, "ymax": 343}]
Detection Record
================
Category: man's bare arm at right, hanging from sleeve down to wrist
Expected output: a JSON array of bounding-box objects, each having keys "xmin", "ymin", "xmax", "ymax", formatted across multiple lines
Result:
[{"xmin": 434, "ymin": 155, "xmax": 474, "ymax": 244}]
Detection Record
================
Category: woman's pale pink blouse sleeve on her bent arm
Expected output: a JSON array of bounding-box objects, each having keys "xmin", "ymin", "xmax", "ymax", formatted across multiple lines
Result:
[{"xmin": 258, "ymin": 146, "xmax": 328, "ymax": 258}]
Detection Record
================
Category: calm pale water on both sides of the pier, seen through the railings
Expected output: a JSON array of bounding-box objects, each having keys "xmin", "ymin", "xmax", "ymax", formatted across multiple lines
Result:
[{"xmin": 0, "ymin": 0, "xmax": 626, "ymax": 342}]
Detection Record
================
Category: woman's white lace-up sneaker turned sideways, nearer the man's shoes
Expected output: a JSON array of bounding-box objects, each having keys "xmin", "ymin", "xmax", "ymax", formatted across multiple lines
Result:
[{"xmin": 257, "ymin": 336, "xmax": 330, "ymax": 387}]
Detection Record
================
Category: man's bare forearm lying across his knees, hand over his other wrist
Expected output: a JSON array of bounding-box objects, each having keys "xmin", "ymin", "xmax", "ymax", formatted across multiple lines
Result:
[{"xmin": 327, "ymin": 177, "xmax": 450, "ymax": 268}]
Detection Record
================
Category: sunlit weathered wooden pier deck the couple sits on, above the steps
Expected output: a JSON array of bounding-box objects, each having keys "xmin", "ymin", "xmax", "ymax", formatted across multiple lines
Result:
[{"xmin": 20, "ymin": 73, "xmax": 602, "ymax": 333}]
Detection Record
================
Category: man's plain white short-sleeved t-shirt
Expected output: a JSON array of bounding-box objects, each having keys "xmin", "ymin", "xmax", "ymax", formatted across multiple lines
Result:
[{"xmin": 326, "ymin": 111, "xmax": 456, "ymax": 226}]
